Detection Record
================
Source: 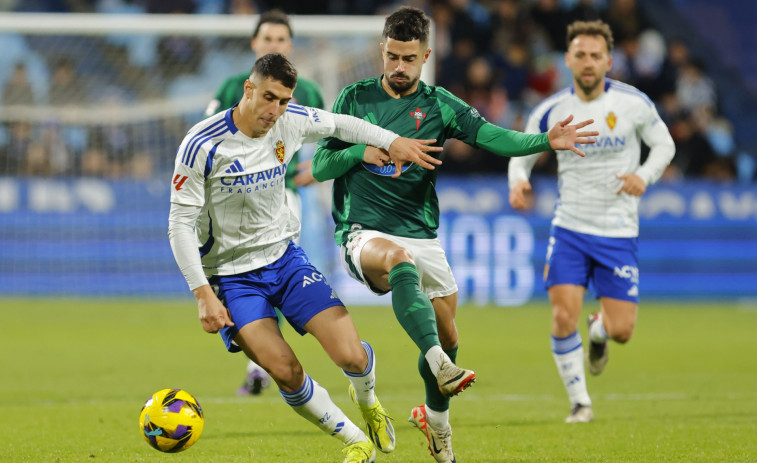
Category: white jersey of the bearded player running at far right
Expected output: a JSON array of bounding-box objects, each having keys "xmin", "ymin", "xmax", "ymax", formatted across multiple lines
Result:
[{"xmin": 508, "ymin": 79, "xmax": 675, "ymax": 238}]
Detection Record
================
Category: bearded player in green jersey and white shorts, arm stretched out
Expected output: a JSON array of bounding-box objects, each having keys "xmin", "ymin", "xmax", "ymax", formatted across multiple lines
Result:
[{"xmin": 312, "ymin": 7, "xmax": 597, "ymax": 462}]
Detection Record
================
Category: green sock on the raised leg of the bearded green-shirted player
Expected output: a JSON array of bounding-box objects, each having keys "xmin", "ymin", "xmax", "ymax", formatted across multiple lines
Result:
[{"xmin": 389, "ymin": 262, "xmax": 439, "ymax": 355}]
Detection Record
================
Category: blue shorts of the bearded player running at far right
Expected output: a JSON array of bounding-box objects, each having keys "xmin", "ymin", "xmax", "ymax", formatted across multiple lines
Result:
[{"xmin": 544, "ymin": 227, "xmax": 639, "ymax": 304}]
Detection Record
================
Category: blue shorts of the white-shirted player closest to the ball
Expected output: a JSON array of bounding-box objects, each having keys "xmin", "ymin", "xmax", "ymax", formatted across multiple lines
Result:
[{"xmin": 209, "ymin": 242, "xmax": 344, "ymax": 352}]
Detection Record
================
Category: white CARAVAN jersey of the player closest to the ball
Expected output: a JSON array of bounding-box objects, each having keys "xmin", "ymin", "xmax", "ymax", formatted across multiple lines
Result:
[{"xmin": 169, "ymin": 103, "xmax": 397, "ymax": 282}]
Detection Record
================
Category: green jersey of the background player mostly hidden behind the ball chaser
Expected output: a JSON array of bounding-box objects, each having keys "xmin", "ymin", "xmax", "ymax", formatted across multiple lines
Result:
[{"xmin": 205, "ymin": 72, "xmax": 324, "ymax": 190}]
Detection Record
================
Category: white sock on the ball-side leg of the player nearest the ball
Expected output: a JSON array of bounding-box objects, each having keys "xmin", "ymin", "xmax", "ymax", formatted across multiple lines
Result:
[{"xmin": 279, "ymin": 375, "xmax": 368, "ymax": 445}]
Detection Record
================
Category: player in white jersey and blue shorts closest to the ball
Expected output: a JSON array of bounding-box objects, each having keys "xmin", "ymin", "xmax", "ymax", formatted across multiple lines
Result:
[{"xmin": 168, "ymin": 53, "xmax": 440, "ymax": 463}]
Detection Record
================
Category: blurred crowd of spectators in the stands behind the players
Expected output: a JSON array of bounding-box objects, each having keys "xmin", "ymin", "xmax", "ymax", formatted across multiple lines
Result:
[{"xmin": 0, "ymin": 0, "xmax": 755, "ymax": 181}]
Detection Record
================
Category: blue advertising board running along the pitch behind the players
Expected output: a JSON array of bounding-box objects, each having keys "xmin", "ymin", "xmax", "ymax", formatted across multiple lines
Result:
[{"xmin": 0, "ymin": 177, "xmax": 757, "ymax": 306}]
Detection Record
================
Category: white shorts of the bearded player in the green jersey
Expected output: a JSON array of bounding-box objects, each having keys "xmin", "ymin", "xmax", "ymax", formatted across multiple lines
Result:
[{"xmin": 342, "ymin": 230, "xmax": 457, "ymax": 299}]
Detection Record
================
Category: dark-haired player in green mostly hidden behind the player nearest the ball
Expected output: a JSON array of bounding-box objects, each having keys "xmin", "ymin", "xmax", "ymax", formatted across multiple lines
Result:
[{"xmin": 205, "ymin": 10, "xmax": 324, "ymax": 395}]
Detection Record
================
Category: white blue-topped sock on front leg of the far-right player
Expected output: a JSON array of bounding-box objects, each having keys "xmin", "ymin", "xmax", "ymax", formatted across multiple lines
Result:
[{"xmin": 552, "ymin": 330, "xmax": 591, "ymax": 406}]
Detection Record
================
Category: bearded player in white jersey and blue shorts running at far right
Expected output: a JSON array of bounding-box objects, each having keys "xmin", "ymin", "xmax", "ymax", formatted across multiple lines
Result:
[{"xmin": 508, "ymin": 21, "xmax": 675, "ymax": 423}]
